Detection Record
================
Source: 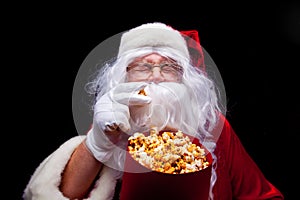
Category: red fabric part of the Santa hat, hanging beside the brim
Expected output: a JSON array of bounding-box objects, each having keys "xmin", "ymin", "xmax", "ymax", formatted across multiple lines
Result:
[{"xmin": 180, "ymin": 30, "xmax": 205, "ymax": 71}]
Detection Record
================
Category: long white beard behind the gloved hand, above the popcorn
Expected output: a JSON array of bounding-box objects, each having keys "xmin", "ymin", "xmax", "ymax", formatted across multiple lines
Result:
[{"xmin": 130, "ymin": 82, "xmax": 199, "ymax": 136}]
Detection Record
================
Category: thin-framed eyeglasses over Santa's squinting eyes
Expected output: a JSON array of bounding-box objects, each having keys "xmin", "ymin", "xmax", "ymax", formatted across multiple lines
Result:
[{"xmin": 127, "ymin": 62, "xmax": 183, "ymax": 80}]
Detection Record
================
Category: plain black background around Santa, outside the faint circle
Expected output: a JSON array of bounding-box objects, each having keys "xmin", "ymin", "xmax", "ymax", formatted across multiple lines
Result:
[{"xmin": 2, "ymin": 1, "xmax": 300, "ymax": 199}]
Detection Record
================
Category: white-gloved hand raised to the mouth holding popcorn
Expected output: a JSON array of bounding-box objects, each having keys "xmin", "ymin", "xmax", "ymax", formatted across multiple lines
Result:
[{"xmin": 86, "ymin": 82, "xmax": 151, "ymax": 170}]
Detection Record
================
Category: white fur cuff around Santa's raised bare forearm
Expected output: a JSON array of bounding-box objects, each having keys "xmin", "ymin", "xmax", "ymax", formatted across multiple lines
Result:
[{"xmin": 23, "ymin": 136, "xmax": 116, "ymax": 200}]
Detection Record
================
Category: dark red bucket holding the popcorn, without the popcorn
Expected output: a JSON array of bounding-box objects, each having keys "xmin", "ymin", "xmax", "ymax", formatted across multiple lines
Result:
[{"xmin": 120, "ymin": 131, "xmax": 213, "ymax": 200}]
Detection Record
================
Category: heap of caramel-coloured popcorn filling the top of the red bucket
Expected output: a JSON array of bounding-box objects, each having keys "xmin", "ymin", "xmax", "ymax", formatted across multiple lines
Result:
[{"xmin": 128, "ymin": 127, "xmax": 210, "ymax": 174}]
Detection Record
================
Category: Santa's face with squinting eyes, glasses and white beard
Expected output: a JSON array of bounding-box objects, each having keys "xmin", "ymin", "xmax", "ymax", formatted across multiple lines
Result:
[{"xmin": 127, "ymin": 53, "xmax": 198, "ymax": 135}]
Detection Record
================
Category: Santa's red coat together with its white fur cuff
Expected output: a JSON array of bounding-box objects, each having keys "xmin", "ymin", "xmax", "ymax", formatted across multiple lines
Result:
[{"xmin": 23, "ymin": 115, "xmax": 284, "ymax": 200}]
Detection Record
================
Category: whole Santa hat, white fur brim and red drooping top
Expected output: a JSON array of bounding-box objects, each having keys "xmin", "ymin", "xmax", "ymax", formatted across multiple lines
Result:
[{"xmin": 118, "ymin": 22, "xmax": 205, "ymax": 71}]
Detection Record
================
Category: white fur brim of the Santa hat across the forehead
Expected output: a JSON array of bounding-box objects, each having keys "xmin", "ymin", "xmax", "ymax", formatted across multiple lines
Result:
[{"xmin": 118, "ymin": 22, "xmax": 189, "ymax": 58}]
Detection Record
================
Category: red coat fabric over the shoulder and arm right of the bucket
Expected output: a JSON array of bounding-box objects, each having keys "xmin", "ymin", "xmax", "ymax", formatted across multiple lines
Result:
[{"xmin": 213, "ymin": 115, "xmax": 284, "ymax": 200}]
